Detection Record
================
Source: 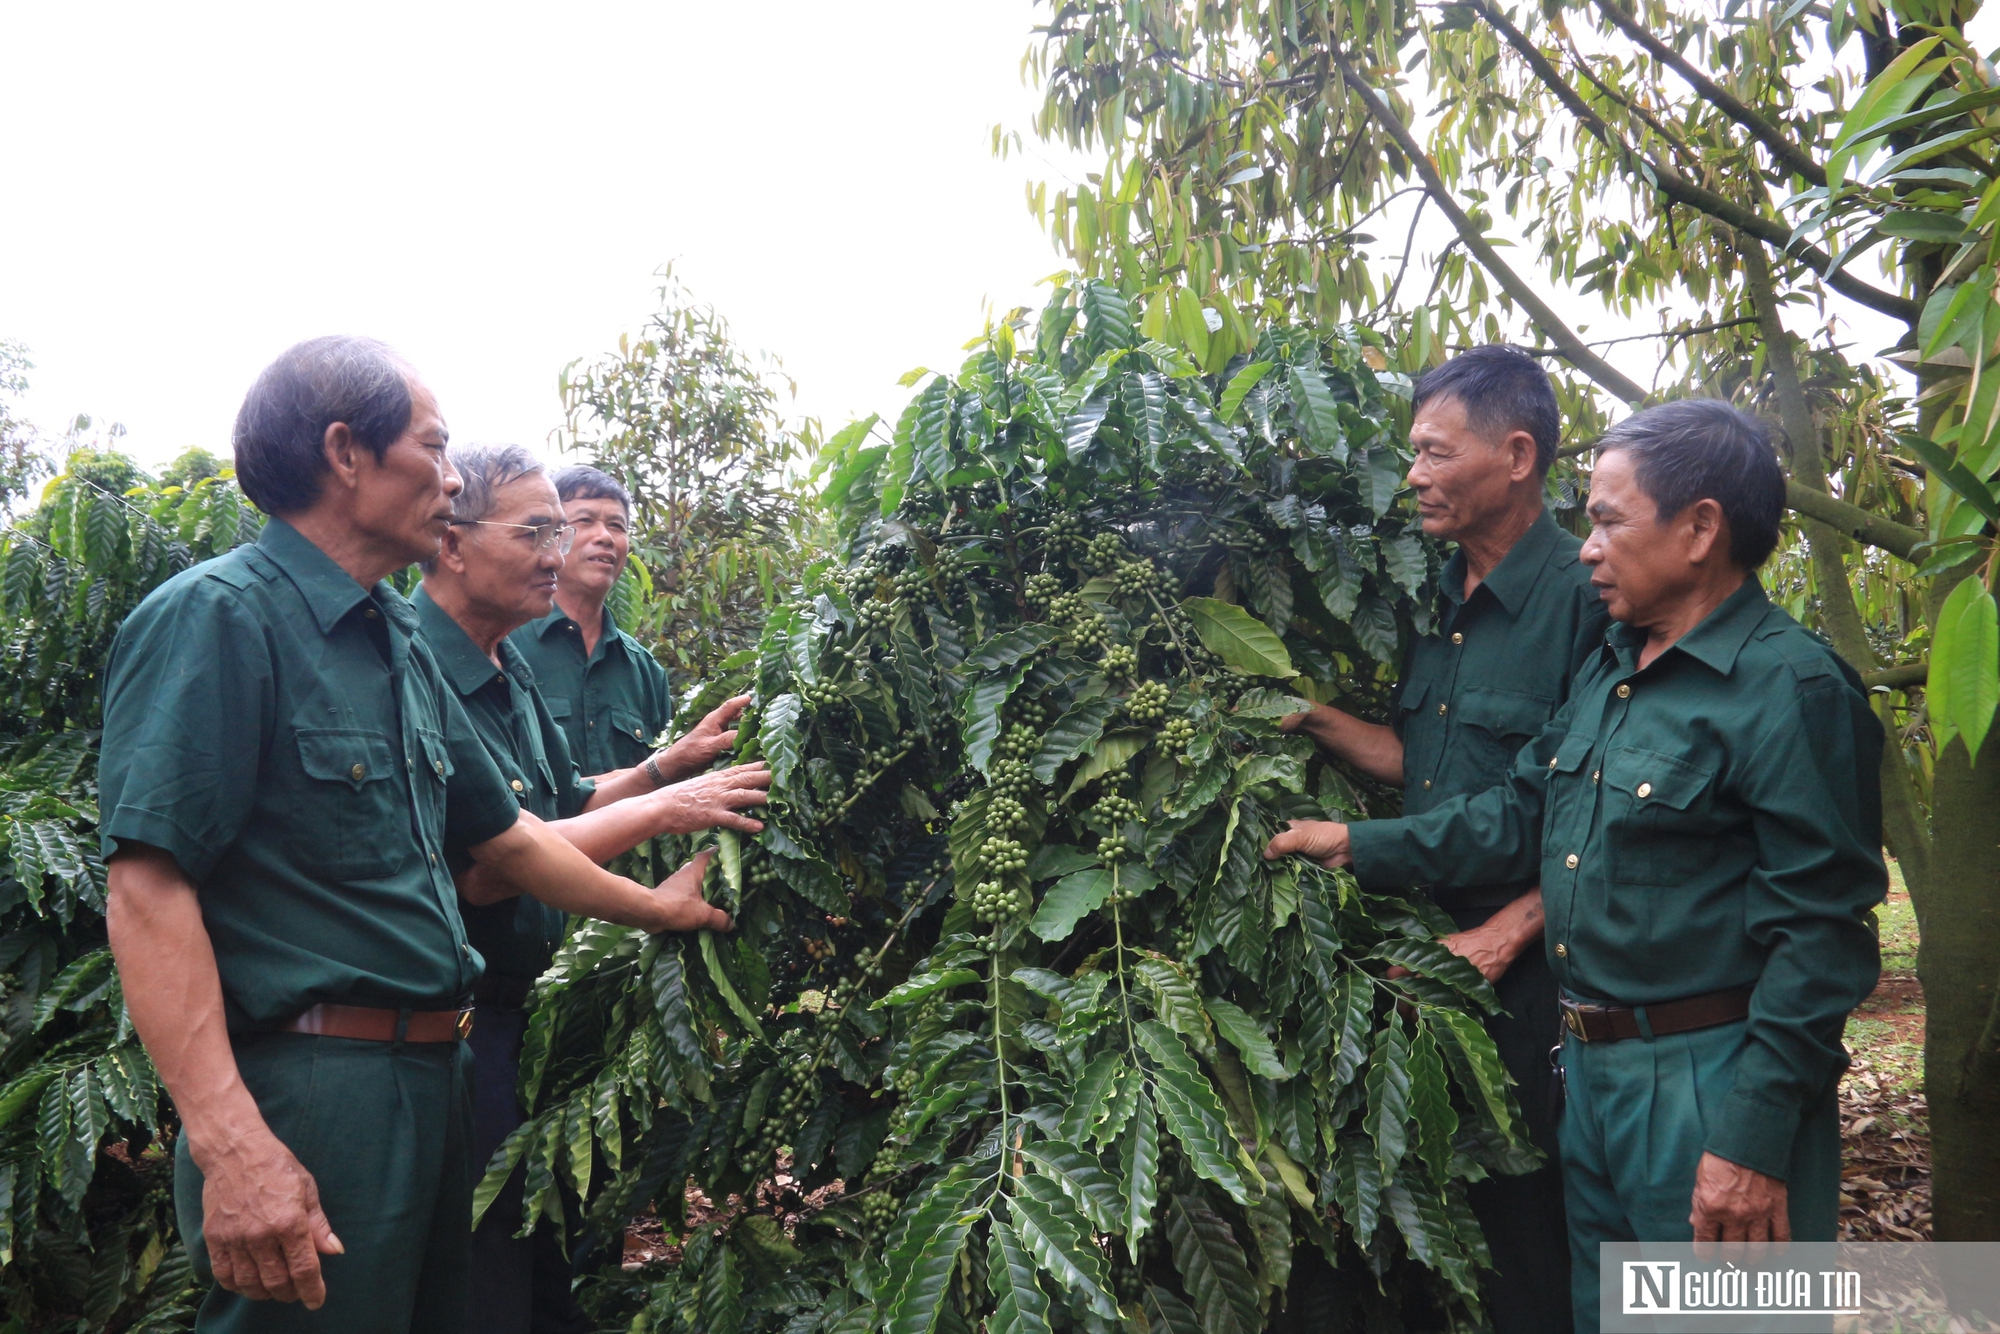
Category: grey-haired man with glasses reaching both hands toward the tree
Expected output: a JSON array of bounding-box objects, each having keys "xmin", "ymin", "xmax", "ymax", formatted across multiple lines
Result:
[{"xmin": 412, "ymin": 446, "xmax": 770, "ymax": 1334}]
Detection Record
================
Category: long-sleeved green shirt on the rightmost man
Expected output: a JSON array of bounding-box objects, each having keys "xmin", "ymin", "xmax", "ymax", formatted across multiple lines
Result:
[{"xmin": 1350, "ymin": 578, "xmax": 1888, "ymax": 1178}]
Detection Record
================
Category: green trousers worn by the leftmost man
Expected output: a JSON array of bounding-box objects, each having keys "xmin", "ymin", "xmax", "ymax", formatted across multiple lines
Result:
[{"xmin": 174, "ymin": 1034, "xmax": 478, "ymax": 1334}]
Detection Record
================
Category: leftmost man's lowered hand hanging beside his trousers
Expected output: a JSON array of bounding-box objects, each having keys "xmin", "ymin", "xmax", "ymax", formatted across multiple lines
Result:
[{"xmin": 196, "ymin": 1132, "xmax": 346, "ymax": 1310}]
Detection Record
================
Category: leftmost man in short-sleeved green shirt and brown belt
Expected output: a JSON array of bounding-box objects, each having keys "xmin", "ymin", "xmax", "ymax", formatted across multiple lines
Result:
[{"xmin": 100, "ymin": 338, "xmax": 728, "ymax": 1334}]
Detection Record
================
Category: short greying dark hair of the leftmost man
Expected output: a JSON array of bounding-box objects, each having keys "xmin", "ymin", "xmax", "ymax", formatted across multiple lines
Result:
[{"xmin": 232, "ymin": 334, "xmax": 416, "ymax": 514}]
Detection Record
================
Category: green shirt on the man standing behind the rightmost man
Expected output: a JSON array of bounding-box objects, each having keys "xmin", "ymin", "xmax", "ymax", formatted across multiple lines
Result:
[{"xmin": 1392, "ymin": 510, "xmax": 1610, "ymax": 908}]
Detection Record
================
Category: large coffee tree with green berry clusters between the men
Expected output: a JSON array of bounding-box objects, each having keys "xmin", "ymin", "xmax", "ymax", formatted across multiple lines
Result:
[{"xmin": 520, "ymin": 284, "xmax": 1532, "ymax": 1334}]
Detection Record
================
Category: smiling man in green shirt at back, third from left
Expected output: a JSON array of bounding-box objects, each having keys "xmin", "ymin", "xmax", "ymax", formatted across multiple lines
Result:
[{"xmin": 514, "ymin": 466, "xmax": 692, "ymax": 774}]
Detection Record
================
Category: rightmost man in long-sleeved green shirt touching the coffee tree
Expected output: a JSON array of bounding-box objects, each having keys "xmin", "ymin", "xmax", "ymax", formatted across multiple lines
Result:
[{"xmin": 1266, "ymin": 400, "xmax": 1888, "ymax": 1330}]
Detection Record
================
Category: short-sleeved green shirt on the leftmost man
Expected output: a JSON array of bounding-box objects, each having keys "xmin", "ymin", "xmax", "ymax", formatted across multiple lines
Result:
[{"xmin": 98, "ymin": 518, "xmax": 520, "ymax": 1032}]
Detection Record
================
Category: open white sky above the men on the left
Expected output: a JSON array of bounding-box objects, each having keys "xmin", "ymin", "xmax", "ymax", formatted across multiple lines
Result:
[{"xmin": 0, "ymin": 0, "xmax": 1088, "ymax": 462}]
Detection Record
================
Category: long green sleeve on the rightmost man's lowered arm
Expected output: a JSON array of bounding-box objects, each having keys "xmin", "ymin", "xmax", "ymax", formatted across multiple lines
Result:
[{"xmin": 1708, "ymin": 674, "xmax": 1888, "ymax": 1178}]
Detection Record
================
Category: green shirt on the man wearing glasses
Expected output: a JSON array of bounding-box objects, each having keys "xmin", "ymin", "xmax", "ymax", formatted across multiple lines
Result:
[{"xmin": 410, "ymin": 588, "xmax": 594, "ymax": 978}]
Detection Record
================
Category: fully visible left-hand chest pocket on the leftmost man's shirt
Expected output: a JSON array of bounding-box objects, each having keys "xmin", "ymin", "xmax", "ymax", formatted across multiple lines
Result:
[{"xmin": 290, "ymin": 728, "xmax": 412, "ymax": 880}]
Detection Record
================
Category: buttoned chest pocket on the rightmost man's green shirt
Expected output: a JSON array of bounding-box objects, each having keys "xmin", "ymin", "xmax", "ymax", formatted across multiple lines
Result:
[{"xmin": 1602, "ymin": 746, "xmax": 1724, "ymax": 886}]
